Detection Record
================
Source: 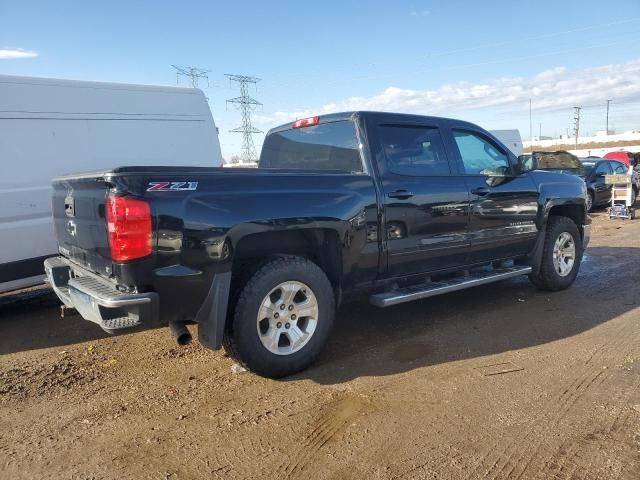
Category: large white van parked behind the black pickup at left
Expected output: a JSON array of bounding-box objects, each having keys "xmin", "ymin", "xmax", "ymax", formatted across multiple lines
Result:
[{"xmin": 0, "ymin": 75, "xmax": 222, "ymax": 292}]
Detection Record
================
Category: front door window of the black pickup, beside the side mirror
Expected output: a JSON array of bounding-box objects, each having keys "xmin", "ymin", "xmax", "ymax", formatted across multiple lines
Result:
[{"xmin": 453, "ymin": 130, "xmax": 509, "ymax": 175}]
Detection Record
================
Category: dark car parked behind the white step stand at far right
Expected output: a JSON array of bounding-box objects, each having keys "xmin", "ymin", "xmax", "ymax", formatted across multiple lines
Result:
[{"xmin": 582, "ymin": 157, "xmax": 640, "ymax": 210}]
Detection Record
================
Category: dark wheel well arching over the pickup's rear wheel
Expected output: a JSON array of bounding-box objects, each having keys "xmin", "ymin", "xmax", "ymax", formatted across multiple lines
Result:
[{"xmin": 231, "ymin": 228, "xmax": 342, "ymax": 290}]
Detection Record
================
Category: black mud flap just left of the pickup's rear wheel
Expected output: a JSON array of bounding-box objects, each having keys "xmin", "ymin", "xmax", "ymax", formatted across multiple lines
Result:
[{"xmin": 195, "ymin": 272, "xmax": 231, "ymax": 350}]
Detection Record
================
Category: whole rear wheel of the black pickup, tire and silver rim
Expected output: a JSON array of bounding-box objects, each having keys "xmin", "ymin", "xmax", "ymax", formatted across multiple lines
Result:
[{"xmin": 224, "ymin": 256, "xmax": 335, "ymax": 378}]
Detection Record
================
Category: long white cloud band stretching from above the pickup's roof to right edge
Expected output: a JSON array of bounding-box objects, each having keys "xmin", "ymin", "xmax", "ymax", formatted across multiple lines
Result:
[{"xmin": 255, "ymin": 59, "xmax": 640, "ymax": 125}]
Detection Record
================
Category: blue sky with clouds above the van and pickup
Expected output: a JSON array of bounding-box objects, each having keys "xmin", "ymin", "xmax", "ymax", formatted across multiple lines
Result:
[{"xmin": 0, "ymin": 0, "xmax": 640, "ymax": 157}]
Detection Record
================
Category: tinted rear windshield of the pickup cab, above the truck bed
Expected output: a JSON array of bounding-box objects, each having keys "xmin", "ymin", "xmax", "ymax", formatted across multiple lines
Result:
[{"xmin": 260, "ymin": 120, "xmax": 362, "ymax": 172}]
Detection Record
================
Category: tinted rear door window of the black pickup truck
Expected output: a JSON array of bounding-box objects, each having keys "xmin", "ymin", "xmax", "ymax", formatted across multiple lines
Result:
[{"xmin": 379, "ymin": 125, "xmax": 451, "ymax": 177}]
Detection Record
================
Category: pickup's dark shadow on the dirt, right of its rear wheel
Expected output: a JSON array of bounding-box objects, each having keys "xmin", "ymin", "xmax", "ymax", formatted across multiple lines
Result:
[{"xmin": 292, "ymin": 247, "xmax": 640, "ymax": 385}]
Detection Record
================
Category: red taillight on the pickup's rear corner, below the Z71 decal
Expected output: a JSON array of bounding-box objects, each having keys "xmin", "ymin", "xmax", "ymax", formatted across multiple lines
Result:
[{"xmin": 106, "ymin": 196, "xmax": 151, "ymax": 262}]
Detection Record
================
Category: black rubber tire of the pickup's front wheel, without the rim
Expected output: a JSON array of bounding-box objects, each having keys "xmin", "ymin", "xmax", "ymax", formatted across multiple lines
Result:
[{"xmin": 529, "ymin": 216, "xmax": 583, "ymax": 292}]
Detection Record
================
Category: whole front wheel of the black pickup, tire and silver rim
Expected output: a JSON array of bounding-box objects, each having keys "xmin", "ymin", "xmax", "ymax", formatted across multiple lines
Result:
[{"xmin": 529, "ymin": 217, "xmax": 582, "ymax": 291}]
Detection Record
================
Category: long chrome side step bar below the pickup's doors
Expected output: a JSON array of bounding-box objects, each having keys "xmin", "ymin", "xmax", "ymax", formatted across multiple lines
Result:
[{"xmin": 369, "ymin": 266, "xmax": 531, "ymax": 307}]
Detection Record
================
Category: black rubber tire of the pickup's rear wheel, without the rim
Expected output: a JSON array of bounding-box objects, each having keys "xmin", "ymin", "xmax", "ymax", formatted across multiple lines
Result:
[{"xmin": 223, "ymin": 256, "xmax": 336, "ymax": 378}]
